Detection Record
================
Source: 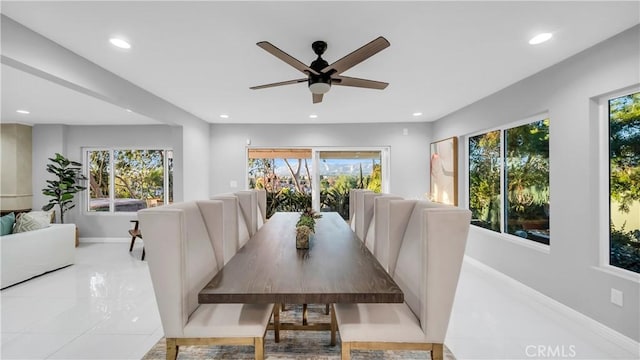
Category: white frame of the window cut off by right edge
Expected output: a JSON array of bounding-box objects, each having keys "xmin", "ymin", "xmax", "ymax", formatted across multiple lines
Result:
[{"xmin": 595, "ymin": 84, "xmax": 640, "ymax": 283}]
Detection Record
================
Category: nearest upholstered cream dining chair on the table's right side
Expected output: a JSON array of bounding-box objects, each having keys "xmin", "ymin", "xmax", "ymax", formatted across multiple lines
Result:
[{"xmin": 334, "ymin": 200, "xmax": 471, "ymax": 360}]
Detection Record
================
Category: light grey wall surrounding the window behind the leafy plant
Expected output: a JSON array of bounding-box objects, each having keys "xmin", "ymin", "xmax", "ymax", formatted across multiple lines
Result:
[{"xmin": 33, "ymin": 125, "xmax": 182, "ymax": 238}]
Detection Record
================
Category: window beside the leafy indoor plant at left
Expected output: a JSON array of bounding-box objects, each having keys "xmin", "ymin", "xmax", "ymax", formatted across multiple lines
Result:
[{"xmin": 86, "ymin": 149, "xmax": 173, "ymax": 212}]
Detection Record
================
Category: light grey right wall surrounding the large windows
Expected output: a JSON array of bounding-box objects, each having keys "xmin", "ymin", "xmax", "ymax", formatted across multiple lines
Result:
[{"xmin": 433, "ymin": 26, "xmax": 640, "ymax": 341}]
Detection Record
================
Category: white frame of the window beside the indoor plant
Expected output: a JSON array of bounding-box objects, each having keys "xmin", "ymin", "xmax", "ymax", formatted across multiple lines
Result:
[{"xmin": 81, "ymin": 146, "xmax": 175, "ymax": 216}]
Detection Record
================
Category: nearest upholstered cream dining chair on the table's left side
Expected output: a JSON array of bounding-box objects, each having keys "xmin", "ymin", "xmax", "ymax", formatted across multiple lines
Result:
[{"xmin": 138, "ymin": 200, "xmax": 273, "ymax": 360}]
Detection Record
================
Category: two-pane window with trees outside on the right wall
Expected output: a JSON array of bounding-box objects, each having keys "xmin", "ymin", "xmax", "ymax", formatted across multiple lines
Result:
[{"xmin": 468, "ymin": 119, "xmax": 550, "ymax": 245}]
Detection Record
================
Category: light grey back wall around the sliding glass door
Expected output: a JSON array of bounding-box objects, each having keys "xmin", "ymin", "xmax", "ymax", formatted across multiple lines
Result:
[{"xmin": 210, "ymin": 123, "xmax": 431, "ymax": 198}]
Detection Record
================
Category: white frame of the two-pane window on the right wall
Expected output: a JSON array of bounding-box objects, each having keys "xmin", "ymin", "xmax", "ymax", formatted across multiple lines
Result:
[{"xmin": 464, "ymin": 111, "xmax": 551, "ymax": 249}]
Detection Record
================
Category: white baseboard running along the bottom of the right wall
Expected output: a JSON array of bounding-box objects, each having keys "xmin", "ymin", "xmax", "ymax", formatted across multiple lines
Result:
[{"xmin": 464, "ymin": 255, "xmax": 640, "ymax": 354}]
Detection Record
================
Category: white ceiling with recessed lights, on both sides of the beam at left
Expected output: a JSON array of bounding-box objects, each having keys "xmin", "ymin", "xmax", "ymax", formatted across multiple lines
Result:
[{"xmin": 1, "ymin": 1, "xmax": 640, "ymax": 124}]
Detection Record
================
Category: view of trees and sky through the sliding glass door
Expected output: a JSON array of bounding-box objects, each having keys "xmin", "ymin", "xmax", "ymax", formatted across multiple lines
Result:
[{"xmin": 248, "ymin": 149, "xmax": 382, "ymax": 219}]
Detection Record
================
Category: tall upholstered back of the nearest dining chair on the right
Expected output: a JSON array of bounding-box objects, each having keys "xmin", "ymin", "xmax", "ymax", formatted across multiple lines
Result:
[{"xmin": 390, "ymin": 200, "xmax": 471, "ymax": 343}]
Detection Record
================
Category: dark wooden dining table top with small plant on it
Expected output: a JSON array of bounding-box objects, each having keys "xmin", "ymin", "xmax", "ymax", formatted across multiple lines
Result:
[{"xmin": 198, "ymin": 212, "xmax": 404, "ymax": 304}]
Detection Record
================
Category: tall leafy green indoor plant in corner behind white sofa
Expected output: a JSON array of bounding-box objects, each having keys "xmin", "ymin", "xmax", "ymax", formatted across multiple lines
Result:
[{"xmin": 42, "ymin": 153, "xmax": 87, "ymax": 223}]
